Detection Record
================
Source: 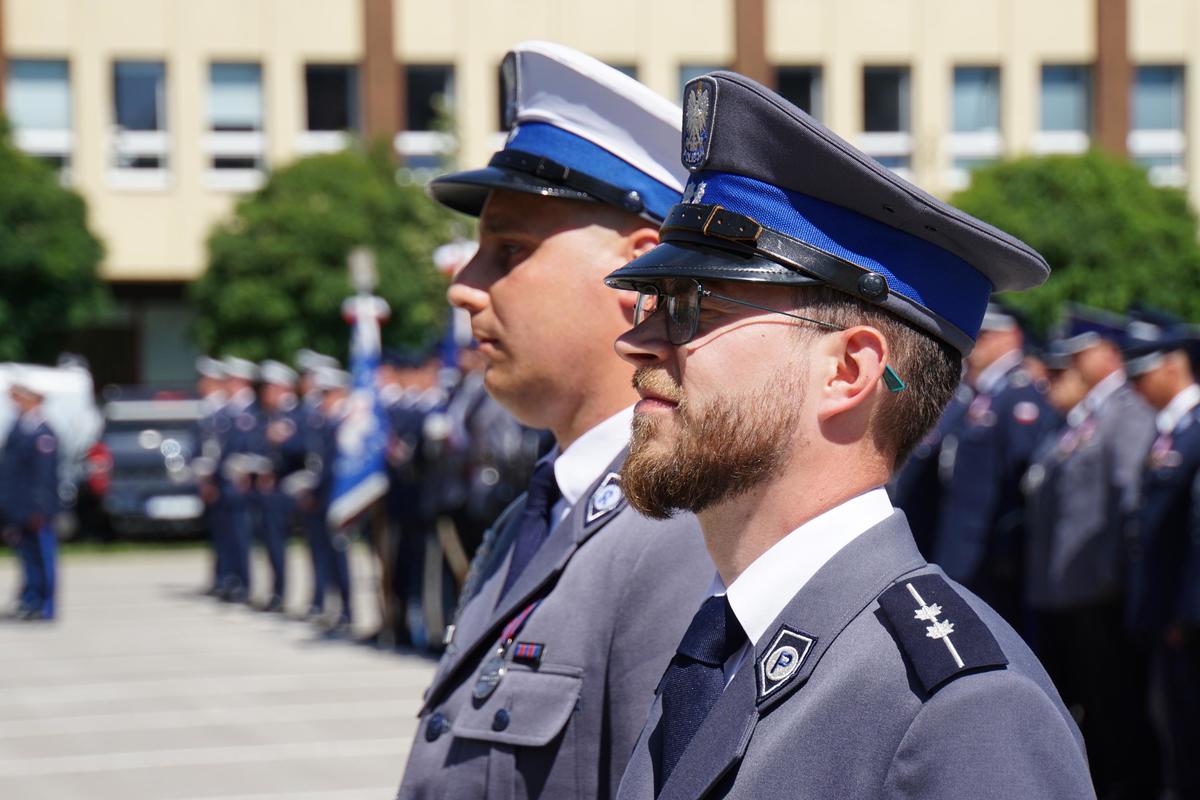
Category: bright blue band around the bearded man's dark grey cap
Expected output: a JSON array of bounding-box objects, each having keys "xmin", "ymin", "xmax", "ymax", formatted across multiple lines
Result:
[{"xmin": 684, "ymin": 172, "xmax": 991, "ymax": 338}]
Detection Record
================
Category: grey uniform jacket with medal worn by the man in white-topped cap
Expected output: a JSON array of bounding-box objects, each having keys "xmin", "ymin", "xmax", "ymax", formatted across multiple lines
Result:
[{"xmin": 397, "ymin": 453, "xmax": 713, "ymax": 800}]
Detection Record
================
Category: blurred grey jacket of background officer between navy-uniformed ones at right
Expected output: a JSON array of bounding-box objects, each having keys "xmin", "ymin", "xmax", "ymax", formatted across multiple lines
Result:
[{"xmin": 1025, "ymin": 383, "xmax": 1156, "ymax": 609}]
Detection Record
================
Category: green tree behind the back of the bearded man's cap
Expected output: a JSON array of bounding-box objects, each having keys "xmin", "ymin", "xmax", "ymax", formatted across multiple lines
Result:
[{"xmin": 952, "ymin": 151, "xmax": 1200, "ymax": 330}]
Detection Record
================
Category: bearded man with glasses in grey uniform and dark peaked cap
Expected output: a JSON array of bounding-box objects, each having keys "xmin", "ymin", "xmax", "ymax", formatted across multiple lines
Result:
[{"xmin": 608, "ymin": 72, "xmax": 1094, "ymax": 800}]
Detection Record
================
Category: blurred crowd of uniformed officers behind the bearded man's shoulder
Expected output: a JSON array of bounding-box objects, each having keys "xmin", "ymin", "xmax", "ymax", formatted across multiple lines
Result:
[{"xmin": 889, "ymin": 305, "xmax": 1200, "ymax": 798}]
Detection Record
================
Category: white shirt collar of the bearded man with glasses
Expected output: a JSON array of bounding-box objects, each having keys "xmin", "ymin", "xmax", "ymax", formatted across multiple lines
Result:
[{"xmin": 709, "ymin": 488, "xmax": 895, "ymax": 645}]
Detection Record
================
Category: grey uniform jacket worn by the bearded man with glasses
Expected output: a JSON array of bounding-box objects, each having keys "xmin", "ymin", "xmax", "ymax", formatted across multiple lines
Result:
[{"xmin": 618, "ymin": 512, "xmax": 1094, "ymax": 800}]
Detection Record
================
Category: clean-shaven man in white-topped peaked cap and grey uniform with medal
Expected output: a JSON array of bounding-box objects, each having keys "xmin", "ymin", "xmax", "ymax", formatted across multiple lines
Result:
[{"xmin": 400, "ymin": 42, "xmax": 712, "ymax": 800}]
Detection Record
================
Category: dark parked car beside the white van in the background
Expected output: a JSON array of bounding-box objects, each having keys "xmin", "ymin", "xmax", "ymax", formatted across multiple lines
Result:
[{"xmin": 86, "ymin": 390, "xmax": 204, "ymax": 537}]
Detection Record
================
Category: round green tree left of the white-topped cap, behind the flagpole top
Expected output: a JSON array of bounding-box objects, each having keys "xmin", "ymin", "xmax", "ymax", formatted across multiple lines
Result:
[{"xmin": 192, "ymin": 146, "xmax": 456, "ymax": 360}]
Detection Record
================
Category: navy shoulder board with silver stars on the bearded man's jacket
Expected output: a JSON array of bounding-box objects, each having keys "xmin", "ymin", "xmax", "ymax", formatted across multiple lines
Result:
[{"xmin": 880, "ymin": 575, "xmax": 1008, "ymax": 694}]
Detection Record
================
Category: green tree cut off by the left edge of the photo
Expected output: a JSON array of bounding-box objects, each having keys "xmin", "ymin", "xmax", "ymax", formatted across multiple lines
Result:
[{"xmin": 0, "ymin": 119, "xmax": 110, "ymax": 362}]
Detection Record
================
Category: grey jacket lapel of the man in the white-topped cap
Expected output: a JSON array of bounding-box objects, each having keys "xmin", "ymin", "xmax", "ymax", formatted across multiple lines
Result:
[{"xmin": 422, "ymin": 451, "xmax": 625, "ymax": 712}]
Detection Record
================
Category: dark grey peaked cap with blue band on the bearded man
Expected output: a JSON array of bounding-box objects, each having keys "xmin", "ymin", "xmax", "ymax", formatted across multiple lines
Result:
[{"xmin": 607, "ymin": 72, "xmax": 1050, "ymax": 353}]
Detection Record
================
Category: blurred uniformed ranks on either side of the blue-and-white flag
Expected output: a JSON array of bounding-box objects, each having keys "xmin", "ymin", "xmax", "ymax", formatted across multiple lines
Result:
[{"xmin": 192, "ymin": 349, "xmax": 546, "ymax": 651}]
